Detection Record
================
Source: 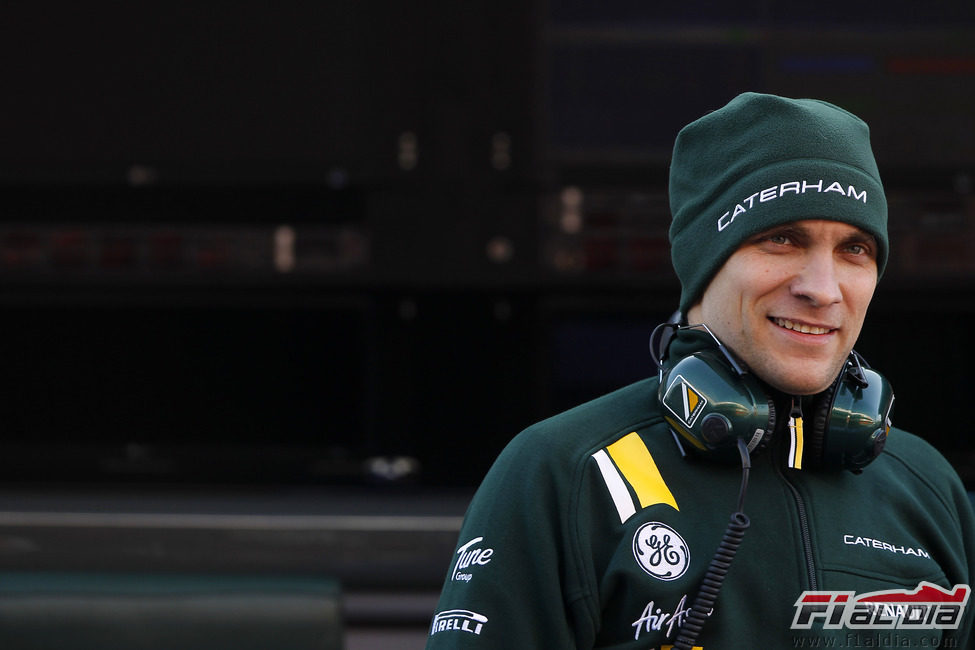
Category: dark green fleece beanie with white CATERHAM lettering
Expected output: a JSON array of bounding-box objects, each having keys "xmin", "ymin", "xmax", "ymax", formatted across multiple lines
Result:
[{"xmin": 670, "ymin": 93, "xmax": 888, "ymax": 314}]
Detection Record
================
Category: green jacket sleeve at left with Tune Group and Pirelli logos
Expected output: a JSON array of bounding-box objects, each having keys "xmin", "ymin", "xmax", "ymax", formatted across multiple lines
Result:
[{"xmin": 427, "ymin": 433, "xmax": 594, "ymax": 650}]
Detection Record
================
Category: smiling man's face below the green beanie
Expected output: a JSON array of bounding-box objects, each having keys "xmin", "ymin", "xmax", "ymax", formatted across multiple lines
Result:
[{"xmin": 687, "ymin": 219, "xmax": 877, "ymax": 395}]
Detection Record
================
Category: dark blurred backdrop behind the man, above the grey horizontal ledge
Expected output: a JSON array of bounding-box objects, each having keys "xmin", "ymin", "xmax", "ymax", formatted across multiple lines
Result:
[{"xmin": 0, "ymin": 0, "xmax": 975, "ymax": 644}]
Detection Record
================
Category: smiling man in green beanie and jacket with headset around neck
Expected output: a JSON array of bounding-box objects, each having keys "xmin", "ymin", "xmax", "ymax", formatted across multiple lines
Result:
[{"xmin": 428, "ymin": 93, "xmax": 975, "ymax": 650}]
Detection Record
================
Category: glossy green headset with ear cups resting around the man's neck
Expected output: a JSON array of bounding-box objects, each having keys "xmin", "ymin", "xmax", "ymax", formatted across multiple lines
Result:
[{"xmin": 650, "ymin": 312, "xmax": 894, "ymax": 474}]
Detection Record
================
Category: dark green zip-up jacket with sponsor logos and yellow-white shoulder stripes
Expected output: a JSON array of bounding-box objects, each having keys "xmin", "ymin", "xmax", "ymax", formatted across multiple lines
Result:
[{"xmin": 427, "ymin": 378, "xmax": 975, "ymax": 650}]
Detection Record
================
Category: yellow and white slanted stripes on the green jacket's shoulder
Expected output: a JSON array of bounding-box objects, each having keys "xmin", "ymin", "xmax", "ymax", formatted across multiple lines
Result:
[{"xmin": 592, "ymin": 431, "xmax": 680, "ymax": 523}]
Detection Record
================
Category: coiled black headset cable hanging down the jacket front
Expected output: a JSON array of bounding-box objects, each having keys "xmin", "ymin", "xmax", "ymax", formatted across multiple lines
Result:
[{"xmin": 674, "ymin": 438, "xmax": 751, "ymax": 650}]
